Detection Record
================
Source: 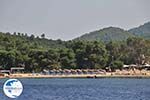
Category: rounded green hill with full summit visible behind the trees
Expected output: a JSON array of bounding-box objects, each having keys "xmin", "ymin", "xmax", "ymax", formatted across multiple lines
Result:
[{"xmin": 75, "ymin": 27, "xmax": 134, "ymax": 42}]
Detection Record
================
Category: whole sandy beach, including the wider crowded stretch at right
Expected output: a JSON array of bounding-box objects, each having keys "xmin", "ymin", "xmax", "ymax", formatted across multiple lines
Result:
[{"xmin": 0, "ymin": 70, "xmax": 150, "ymax": 78}]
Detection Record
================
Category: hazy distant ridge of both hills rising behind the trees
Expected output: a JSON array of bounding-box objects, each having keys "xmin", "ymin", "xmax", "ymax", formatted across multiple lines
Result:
[{"xmin": 74, "ymin": 22, "xmax": 150, "ymax": 42}]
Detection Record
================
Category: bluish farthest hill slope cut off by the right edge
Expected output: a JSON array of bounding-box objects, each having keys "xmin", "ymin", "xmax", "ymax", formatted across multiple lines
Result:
[{"xmin": 129, "ymin": 22, "xmax": 150, "ymax": 39}]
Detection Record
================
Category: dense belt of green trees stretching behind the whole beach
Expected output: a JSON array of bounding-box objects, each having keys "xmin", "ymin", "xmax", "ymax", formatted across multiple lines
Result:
[{"xmin": 0, "ymin": 32, "xmax": 150, "ymax": 72}]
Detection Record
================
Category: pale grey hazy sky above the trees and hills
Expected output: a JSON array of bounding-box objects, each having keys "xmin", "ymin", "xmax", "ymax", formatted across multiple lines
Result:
[{"xmin": 0, "ymin": 0, "xmax": 150, "ymax": 40}]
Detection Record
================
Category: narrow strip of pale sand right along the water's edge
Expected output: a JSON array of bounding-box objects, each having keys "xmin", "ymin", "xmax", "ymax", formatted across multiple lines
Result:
[{"xmin": 0, "ymin": 74, "xmax": 150, "ymax": 79}]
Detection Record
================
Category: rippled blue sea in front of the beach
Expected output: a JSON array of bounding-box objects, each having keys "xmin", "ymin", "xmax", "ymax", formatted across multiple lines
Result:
[{"xmin": 0, "ymin": 78, "xmax": 150, "ymax": 100}]
